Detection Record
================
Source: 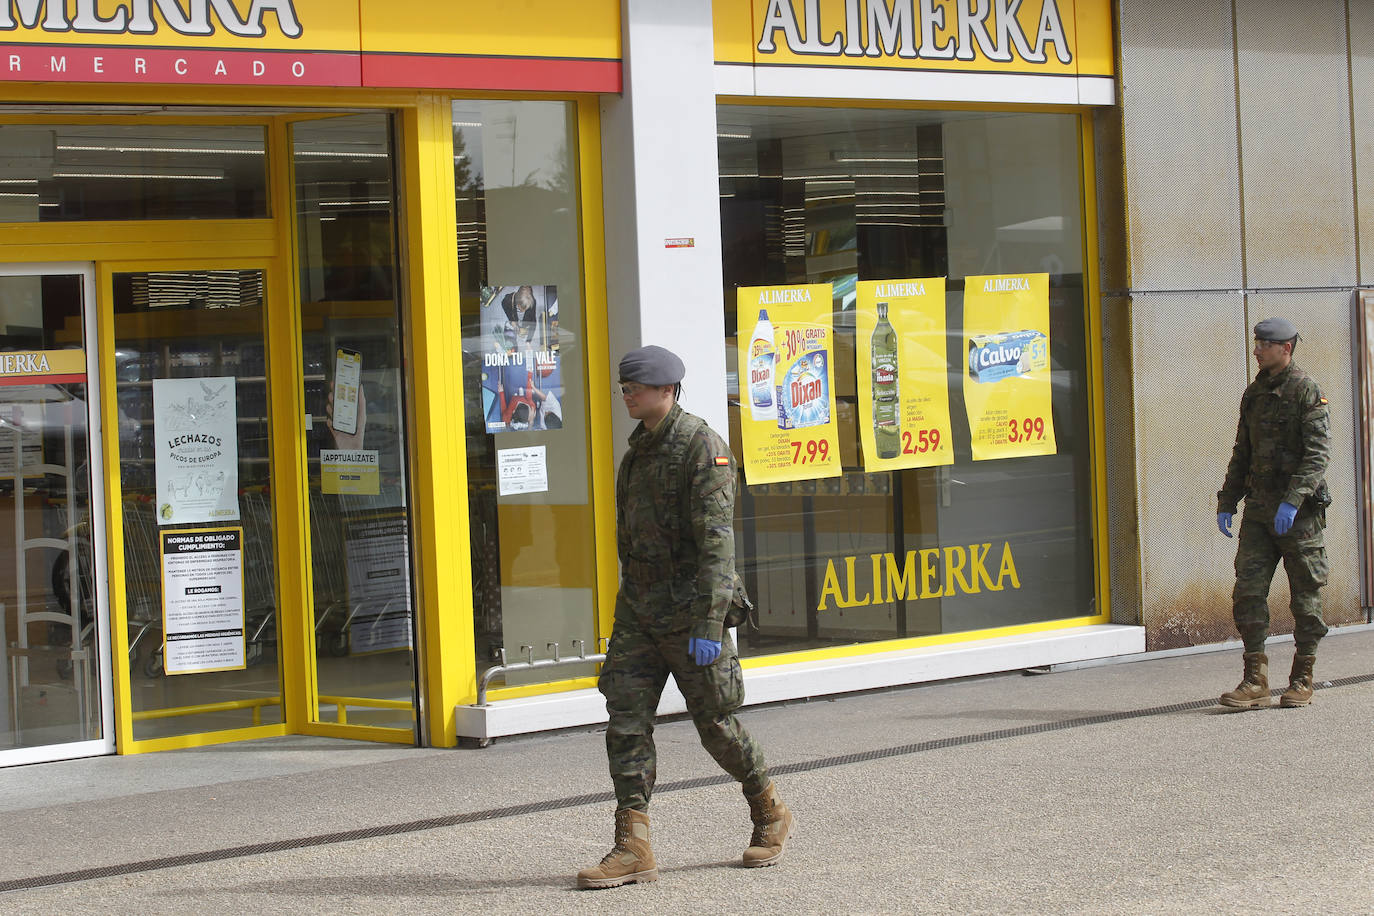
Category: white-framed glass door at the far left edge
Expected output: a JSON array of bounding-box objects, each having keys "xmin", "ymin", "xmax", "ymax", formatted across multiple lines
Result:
[{"xmin": 0, "ymin": 265, "xmax": 114, "ymax": 766}]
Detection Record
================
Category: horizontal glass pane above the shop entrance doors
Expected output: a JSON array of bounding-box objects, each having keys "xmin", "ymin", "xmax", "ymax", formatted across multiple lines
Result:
[{"xmin": 0, "ymin": 124, "xmax": 268, "ymax": 222}]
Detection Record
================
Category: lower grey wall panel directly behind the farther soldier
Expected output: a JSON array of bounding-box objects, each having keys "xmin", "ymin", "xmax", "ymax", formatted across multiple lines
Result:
[{"xmin": 1248, "ymin": 293, "xmax": 1364, "ymax": 633}]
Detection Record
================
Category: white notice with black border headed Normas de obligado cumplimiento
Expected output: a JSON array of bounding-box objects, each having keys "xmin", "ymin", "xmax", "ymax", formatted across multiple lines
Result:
[{"xmin": 162, "ymin": 527, "xmax": 246, "ymax": 674}]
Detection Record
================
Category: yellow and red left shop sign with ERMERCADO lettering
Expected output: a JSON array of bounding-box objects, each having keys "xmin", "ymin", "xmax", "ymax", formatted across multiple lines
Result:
[{"xmin": 0, "ymin": 0, "xmax": 621, "ymax": 92}]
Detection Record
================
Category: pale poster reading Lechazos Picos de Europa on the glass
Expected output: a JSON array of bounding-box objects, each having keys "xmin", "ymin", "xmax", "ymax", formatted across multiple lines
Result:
[{"xmin": 153, "ymin": 376, "xmax": 239, "ymax": 525}]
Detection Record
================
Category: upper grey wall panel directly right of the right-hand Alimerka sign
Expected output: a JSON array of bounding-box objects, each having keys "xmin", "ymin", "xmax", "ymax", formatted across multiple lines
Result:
[{"xmin": 1120, "ymin": 0, "xmax": 1242, "ymax": 290}]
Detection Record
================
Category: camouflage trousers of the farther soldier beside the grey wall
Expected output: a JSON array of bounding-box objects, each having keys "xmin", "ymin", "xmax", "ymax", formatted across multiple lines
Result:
[{"xmin": 1231, "ymin": 514, "xmax": 1326, "ymax": 655}]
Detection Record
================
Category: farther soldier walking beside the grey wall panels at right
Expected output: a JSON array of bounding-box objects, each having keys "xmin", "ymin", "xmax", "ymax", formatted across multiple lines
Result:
[{"xmin": 1216, "ymin": 319, "xmax": 1331, "ymax": 709}]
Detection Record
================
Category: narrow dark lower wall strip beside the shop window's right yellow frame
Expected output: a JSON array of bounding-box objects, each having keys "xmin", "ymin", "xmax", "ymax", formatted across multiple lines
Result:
[{"xmin": 1102, "ymin": 297, "xmax": 1142, "ymax": 626}]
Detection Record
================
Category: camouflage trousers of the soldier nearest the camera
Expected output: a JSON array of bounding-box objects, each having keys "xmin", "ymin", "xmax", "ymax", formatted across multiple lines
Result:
[{"xmin": 598, "ymin": 615, "xmax": 768, "ymax": 810}]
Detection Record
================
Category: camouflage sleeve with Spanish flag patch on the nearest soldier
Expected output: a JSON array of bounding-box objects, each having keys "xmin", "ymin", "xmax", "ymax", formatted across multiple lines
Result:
[{"xmin": 687, "ymin": 430, "xmax": 735, "ymax": 643}]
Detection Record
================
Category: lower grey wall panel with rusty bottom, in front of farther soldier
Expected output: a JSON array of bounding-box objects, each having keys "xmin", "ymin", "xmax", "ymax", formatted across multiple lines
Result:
[{"xmin": 1132, "ymin": 293, "xmax": 1249, "ymax": 650}]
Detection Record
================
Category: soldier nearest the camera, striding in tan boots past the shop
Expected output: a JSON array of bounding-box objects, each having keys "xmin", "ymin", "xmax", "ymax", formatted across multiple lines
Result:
[{"xmin": 577, "ymin": 346, "xmax": 791, "ymax": 887}]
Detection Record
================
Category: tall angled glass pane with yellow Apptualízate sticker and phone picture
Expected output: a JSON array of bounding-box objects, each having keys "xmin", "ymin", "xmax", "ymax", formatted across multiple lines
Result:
[{"xmin": 291, "ymin": 113, "xmax": 415, "ymax": 733}]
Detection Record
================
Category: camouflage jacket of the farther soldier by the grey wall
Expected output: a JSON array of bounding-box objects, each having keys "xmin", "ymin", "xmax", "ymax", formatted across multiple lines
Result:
[{"xmin": 1216, "ymin": 363, "xmax": 1331, "ymax": 515}]
